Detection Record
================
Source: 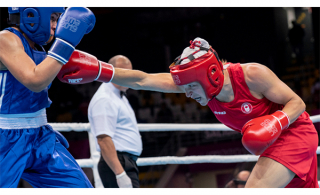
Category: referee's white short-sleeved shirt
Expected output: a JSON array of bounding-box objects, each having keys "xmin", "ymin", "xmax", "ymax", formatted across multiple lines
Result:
[{"xmin": 88, "ymin": 82, "xmax": 142, "ymax": 156}]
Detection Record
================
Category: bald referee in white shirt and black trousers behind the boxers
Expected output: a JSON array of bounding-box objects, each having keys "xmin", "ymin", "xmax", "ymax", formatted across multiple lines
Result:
[{"xmin": 88, "ymin": 55, "xmax": 142, "ymax": 188}]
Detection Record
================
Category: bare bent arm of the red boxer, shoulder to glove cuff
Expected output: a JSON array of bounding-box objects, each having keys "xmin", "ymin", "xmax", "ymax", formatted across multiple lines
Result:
[{"xmin": 244, "ymin": 64, "xmax": 306, "ymax": 124}]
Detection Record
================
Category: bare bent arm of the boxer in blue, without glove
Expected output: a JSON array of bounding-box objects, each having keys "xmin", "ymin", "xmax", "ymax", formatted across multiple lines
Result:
[{"xmin": 0, "ymin": 31, "xmax": 62, "ymax": 92}]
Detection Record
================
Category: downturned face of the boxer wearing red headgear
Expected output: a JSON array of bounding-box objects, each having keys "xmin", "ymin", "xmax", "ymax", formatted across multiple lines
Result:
[{"xmin": 183, "ymin": 82, "xmax": 208, "ymax": 106}]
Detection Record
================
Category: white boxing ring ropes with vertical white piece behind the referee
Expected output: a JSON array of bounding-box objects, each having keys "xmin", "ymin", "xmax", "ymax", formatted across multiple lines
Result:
[{"xmin": 50, "ymin": 115, "xmax": 320, "ymax": 188}]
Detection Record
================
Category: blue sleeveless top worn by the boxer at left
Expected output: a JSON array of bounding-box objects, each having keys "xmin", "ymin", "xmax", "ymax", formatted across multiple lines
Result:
[{"xmin": 0, "ymin": 28, "xmax": 51, "ymax": 114}]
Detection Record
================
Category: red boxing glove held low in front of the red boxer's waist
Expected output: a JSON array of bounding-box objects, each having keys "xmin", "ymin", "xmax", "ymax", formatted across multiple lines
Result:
[{"xmin": 241, "ymin": 110, "xmax": 290, "ymax": 155}]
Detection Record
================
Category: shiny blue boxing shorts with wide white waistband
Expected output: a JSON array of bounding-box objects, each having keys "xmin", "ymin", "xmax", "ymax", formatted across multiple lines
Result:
[{"xmin": 0, "ymin": 109, "xmax": 92, "ymax": 188}]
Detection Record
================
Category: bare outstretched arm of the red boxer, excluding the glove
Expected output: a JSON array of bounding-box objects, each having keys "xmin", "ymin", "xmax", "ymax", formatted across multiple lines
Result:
[{"xmin": 111, "ymin": 68, "xmax": 184, "ymax": 93}]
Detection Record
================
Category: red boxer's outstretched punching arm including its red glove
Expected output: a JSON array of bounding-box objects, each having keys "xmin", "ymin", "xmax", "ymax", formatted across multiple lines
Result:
[{"xmin": 57, "ymin": 50, "xmax": 184, "ymax": 93}]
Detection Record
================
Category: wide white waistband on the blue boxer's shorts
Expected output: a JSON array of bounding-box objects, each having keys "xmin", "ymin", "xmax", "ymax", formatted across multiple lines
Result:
[{"xmin": 0, "ymin": 108, "xmax": 48, "ymax": 129}]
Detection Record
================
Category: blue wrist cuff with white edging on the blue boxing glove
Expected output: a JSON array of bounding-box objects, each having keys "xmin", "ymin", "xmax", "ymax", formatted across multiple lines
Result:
[{"xmin": 48, "ymin": 38, "xmax": 75, "ymax": 65}]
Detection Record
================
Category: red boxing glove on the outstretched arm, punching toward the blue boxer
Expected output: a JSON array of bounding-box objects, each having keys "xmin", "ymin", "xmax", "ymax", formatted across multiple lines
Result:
[{"xmin": 57, "ymin": 50, "xmax": 114, "ymax": 84}]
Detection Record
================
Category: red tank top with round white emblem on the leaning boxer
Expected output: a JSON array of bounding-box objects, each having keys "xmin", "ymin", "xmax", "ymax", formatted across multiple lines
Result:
[{"xmin": 208, "ymin": 63, "xmax": 283, "ymax": 132}]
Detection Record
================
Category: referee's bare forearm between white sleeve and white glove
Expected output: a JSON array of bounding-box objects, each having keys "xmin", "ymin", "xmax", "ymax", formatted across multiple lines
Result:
[{"xmin": 97, "ymin": 134, "xmax": 124, "ymax": 175}]
